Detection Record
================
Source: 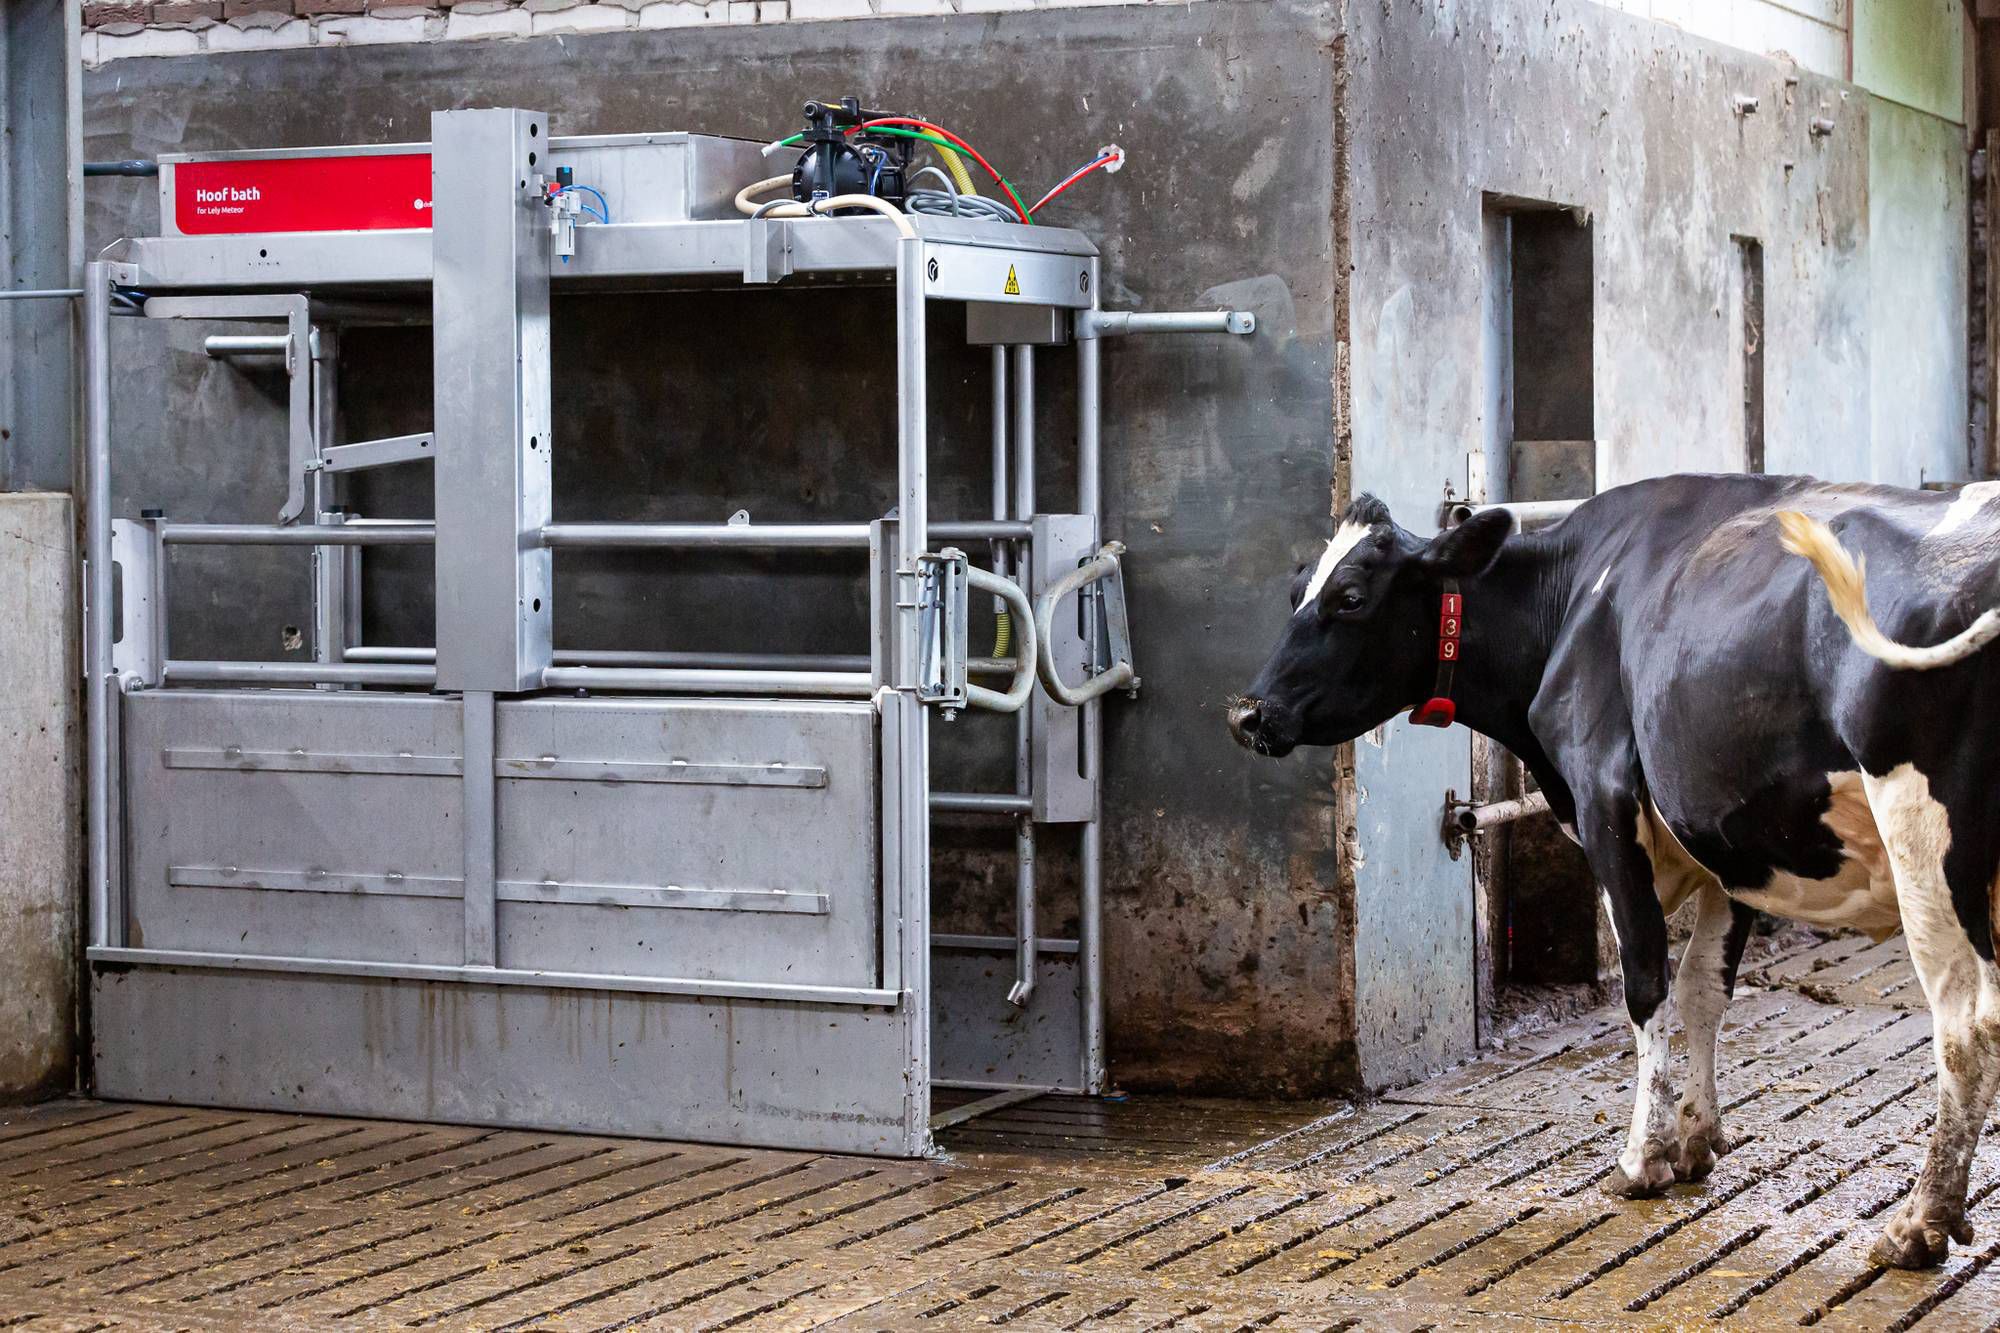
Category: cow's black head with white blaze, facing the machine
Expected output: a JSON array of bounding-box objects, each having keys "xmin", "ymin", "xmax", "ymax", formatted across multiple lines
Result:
[{"xmin": 1230, "ymin": 494, "xmax": 1512, "ymax": 755}]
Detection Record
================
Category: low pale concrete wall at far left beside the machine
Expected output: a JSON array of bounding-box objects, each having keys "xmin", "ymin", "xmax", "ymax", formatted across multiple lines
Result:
[{"xmin": 0, "ymin": 492, "xmax": 82, "ymax": 1101}]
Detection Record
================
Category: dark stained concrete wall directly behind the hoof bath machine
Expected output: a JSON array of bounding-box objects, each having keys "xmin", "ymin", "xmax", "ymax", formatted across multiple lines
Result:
[{"xmin": 86, "ymin": 2, "xmax": 1352, "ymax": 1091}]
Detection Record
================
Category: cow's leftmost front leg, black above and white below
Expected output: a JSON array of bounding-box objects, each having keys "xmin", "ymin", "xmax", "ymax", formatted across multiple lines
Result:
[{"xmin": 1576, "ymin": 789, "xmax": 1680, "ymax": 1199}]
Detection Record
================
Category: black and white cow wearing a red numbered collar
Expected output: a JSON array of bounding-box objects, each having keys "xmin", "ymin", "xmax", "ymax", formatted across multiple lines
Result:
[{"xmin": 1228, "ymin": 476, "xmax": 2000, "ymax": 1267}]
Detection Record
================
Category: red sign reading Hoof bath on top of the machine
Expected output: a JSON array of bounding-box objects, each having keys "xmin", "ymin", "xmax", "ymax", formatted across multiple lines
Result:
[{"xmin": 174, "ymin": 152, "xmax": 430, "ymax": 236}]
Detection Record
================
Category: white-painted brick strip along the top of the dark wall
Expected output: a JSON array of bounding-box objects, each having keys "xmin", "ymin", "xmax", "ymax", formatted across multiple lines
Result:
[{"xmin": 84, "ymin": 0, "xmax": 1168, "ymax": 66}]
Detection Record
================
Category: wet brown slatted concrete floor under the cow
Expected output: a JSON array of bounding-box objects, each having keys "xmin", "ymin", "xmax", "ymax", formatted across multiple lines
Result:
[{"xmin": 0, "ymin": 928, "xmax": 2000, "ymax": 1333}]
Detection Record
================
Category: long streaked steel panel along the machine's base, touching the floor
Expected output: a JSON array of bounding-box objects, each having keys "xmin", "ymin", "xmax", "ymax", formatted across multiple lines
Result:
[{"xmin": 92, "ymin": 961, "xmax": 930, "ymax": 1157}]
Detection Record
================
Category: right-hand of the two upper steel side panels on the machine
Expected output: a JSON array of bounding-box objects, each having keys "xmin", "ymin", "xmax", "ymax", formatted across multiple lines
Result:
[{"xmin": 496, "ymin": 699, "xmax": 882, "ymax": 987}]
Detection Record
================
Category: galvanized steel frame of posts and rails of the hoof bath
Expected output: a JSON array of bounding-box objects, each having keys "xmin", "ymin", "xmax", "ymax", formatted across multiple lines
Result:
[{"xmin": 82, "ymin": 112, "xmax": 1104, "ymax": 1155}]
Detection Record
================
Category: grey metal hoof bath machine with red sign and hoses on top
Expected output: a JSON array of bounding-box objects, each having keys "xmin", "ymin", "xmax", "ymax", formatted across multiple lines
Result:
[{"xmin": 84, "ymin": 102, "xmax": 1250, "ymax": 1155}]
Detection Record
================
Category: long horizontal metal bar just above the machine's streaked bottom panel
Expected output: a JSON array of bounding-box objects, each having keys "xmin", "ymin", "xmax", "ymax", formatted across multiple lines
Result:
[{"xmin": 88, "ymin": 947, "xmax": 896, "ymax": 1009}]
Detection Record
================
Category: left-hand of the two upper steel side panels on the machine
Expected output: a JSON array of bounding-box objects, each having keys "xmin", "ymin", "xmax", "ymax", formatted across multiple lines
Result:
[{"xmin": 122, "ymin": 691, "xmax": 464, "ymax": 963}]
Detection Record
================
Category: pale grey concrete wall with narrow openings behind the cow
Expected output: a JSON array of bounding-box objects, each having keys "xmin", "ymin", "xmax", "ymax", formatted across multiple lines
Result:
[{"xmin": 1346, "ymin": 0, "xmax": 1966, "ymax": 1083}]
